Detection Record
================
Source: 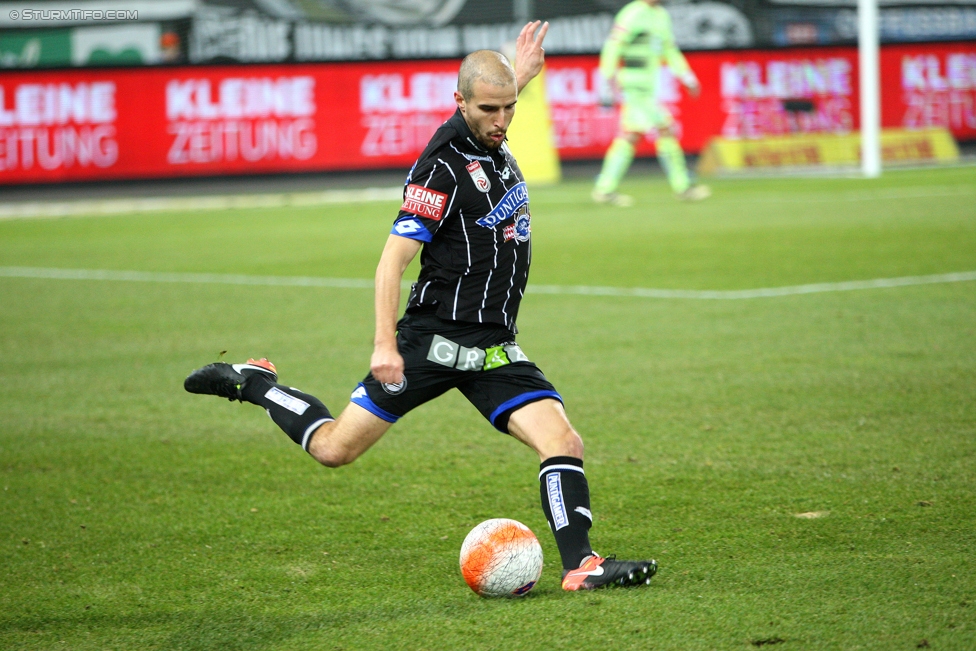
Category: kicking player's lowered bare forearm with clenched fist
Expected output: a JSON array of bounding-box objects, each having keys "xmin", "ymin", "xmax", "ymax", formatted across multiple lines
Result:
[{"xmin": 369, "ymin": 235, "xmax": 422, "ymax": 384}]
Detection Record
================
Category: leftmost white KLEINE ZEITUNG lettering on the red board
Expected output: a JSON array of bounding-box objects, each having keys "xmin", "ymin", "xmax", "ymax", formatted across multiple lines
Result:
[{"xmin": 0, "ymin": 81, "xmax": 119, "ymax": 172}]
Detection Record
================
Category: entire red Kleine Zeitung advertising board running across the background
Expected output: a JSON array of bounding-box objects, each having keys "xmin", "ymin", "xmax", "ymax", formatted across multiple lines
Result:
[{"xmin": 0, "ymin": 43, "xmax": 976, "ymax": 184}]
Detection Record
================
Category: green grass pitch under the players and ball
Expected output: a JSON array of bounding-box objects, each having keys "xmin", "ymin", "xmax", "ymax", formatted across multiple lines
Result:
[{"xmin": 0, "ymin": 167, "xmax": 976, "ymax": 651}]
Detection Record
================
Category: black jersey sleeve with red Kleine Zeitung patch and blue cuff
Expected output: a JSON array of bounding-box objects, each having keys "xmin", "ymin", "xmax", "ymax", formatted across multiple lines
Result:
[{"xmin": 390, "ymin": 159, "xmax": 457, "ymax": 242}]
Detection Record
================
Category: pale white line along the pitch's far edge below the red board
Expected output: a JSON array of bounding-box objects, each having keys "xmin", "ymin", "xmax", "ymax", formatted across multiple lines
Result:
[{"xmin": 0, "ymin": 188, "xmax": 403, "ymax": 220}]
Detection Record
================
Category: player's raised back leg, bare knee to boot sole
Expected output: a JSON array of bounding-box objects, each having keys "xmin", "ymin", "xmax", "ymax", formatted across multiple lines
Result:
[{"xmin": 183, "ymin": 358, "xmax": 392, "ymax": 468}]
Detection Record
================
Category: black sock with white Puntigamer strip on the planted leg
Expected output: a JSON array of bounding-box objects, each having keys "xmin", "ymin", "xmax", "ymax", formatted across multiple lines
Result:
[{"xmin": 539, "ymin": 457, "xmax": 593, "ymax": 570}]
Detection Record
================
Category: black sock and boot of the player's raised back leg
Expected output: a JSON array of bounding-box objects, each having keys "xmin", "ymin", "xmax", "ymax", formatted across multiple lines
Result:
[{"xmin": 183, "ymin": 358, "xmax": 335, "ymax": 452}]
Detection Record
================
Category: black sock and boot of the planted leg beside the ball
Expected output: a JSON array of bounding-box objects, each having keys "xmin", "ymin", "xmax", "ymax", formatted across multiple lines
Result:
[{"xmin": 539, "ymin": 457, "xmax": 657, "ymax": 590}]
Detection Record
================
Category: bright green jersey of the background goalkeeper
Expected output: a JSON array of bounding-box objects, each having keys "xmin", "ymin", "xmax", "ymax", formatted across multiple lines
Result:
[{"xmin": 600, "ymin": 0, "xmax": 691, "ymax": 95}]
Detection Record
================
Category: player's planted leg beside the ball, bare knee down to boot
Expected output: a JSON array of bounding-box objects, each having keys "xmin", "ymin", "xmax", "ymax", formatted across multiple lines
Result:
[{"xmin": 508, "ymin": 399, "xmax": 657, "ymax": 590}]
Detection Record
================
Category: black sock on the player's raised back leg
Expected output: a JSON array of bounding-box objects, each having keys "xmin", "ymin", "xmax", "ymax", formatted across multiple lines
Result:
[{"xmin": 241, "ymin": 374, "xmax": 335, "ymax": 452}]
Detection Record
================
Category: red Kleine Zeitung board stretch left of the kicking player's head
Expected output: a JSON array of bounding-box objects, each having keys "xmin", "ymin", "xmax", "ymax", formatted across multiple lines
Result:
[{"xmin": 0, "ymin": 61, "xmax": 458, "ymax": 183}]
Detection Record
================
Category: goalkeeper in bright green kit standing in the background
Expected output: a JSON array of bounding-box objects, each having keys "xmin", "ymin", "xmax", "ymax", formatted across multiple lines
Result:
[{"xmin": 593, "ymin": 0, "xmax": 711, "ymax": 206}]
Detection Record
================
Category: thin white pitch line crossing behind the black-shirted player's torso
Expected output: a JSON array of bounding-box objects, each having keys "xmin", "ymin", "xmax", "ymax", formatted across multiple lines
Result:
[{"xmin": 0, "ymin": 267, "xmax": 976, "ymax": 300}]
